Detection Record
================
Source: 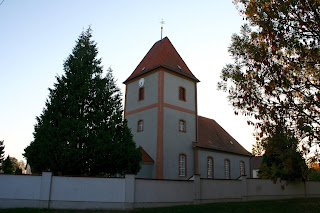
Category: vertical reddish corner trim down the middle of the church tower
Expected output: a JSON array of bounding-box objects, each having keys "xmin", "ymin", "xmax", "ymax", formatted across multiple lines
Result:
[{"xmin": 156, "ymin": 70, "xmax": 164, "ymax": 179}]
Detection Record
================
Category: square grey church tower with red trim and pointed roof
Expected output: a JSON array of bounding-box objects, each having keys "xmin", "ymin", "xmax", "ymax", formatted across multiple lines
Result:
[{"xmin": 124, "ymin": 37, "xmax": 199, "ymax": 179}]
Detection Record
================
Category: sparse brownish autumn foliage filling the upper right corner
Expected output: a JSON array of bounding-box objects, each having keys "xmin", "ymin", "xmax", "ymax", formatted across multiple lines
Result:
[{"xmin": 218, "ymin": 0, "xmax": 320, "ymax": 155}]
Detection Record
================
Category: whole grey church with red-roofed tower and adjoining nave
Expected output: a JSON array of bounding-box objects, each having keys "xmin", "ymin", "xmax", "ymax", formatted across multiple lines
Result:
[{"xmin": 124, "ymin": 37, "xmax": 251, "ymax": 180}]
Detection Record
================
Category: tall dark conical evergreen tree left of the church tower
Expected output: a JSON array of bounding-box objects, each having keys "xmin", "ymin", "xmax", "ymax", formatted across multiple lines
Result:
[{"xmin": 24, "ymin": 28, "xmax": 141, "ymax": 175}]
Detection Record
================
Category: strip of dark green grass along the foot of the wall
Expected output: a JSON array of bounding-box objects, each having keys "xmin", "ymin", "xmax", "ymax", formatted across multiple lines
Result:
[{"xmin": 0, "ymin": 198, "xmax": 320, "ymax": 213}]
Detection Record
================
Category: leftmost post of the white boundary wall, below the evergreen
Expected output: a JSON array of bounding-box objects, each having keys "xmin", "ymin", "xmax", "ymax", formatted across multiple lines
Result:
[{"xmin": 40, "ymin": 172, "xmax": 52, "ymax": 208}]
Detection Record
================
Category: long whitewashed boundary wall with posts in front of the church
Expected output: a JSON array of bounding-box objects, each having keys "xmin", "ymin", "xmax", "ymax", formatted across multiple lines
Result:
[{"xmin": 0, "ymin": 172, "xmax": 320, "ymax": 209}]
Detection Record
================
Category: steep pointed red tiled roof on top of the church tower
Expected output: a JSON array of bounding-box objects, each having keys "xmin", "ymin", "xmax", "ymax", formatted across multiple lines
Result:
[{"xmin": 124, "ymin": 37, "xmax": 199, "ymax": 83}]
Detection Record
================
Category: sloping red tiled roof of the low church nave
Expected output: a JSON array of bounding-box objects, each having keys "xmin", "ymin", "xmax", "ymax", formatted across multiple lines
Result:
[{"xmin": 194, "ymin": 116, "xmax": 251, "ymax": 156}]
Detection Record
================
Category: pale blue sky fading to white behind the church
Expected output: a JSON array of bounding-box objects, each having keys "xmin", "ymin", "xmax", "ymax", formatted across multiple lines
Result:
[{"xmin": 0, "ymin": 0, "xmax": 254, "ymax": 159}]
